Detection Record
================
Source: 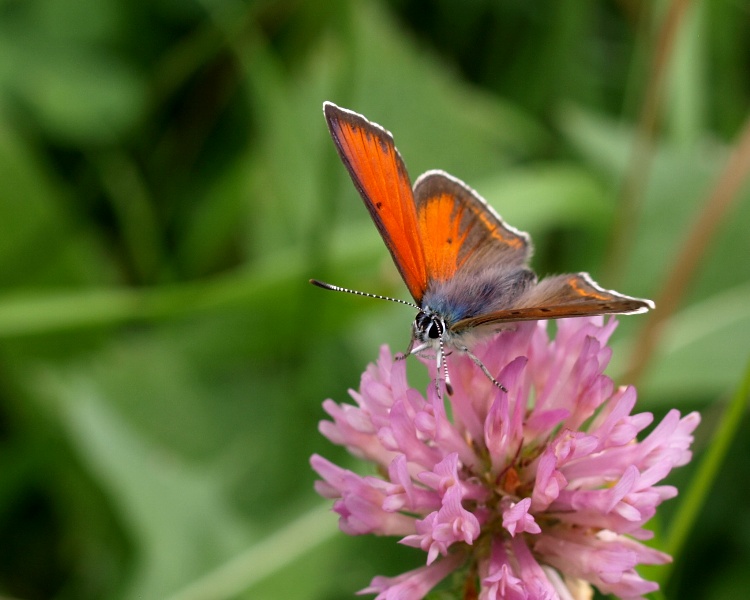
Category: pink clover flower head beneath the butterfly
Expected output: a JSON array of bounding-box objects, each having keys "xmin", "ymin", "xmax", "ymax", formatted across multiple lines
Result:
[{"xmin": 311, "ymin": 317, "xmax": 700, "ymax": 600}]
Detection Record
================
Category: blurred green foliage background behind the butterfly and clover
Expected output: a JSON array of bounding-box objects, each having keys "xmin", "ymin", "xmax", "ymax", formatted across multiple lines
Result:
[{"xmin": 0, "ymin": 0, "xmax": 750, "ymax": 600}]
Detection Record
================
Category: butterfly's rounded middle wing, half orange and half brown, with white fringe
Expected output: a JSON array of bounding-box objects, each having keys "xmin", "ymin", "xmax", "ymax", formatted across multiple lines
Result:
[{"xmin": 414, "ymin": 171, "xmax": 531, "ymax": 282}]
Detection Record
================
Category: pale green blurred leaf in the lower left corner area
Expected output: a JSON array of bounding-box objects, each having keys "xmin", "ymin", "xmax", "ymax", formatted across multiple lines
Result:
[{"xmin": 38, "ymin": 368, "xmax": 252, "ymax": 599}]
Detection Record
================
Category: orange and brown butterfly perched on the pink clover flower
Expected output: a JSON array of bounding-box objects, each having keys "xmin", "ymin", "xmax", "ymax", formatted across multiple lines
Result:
[{"xmin": 310, "ymin": 102, "xmax": 654, "ymax": 394}]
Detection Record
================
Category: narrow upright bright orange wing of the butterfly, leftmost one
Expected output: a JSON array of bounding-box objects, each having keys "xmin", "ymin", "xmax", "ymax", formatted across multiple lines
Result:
[{"xmin": 323, "ymin": 102, "xmax": 428, "ymax": 304}]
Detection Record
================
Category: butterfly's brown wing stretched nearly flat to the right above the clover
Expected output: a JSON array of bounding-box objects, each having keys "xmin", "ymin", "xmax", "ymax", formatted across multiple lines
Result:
[{"xmin": 452, "ymin": 273, "xmax": 654, "ymax": 331}]
